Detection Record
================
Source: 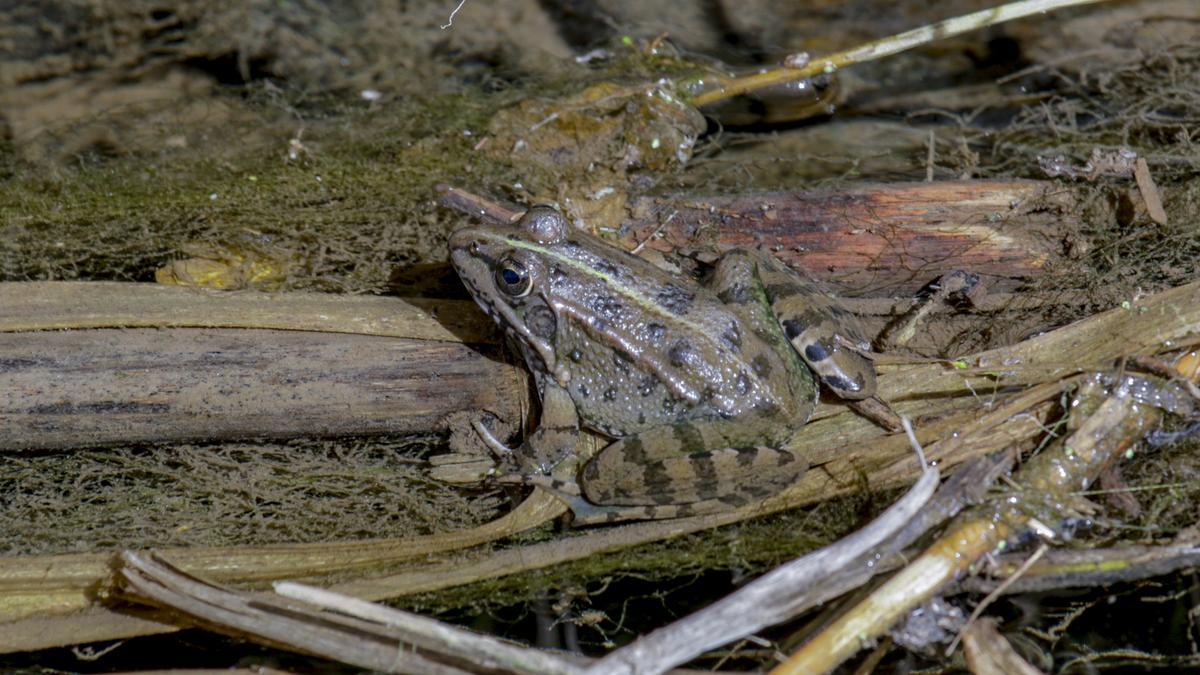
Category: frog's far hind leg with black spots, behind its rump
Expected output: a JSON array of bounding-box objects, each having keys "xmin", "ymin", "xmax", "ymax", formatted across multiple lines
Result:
[{"xmin": 721, "ymin": 251, "xmax": 875, "ymax": 401}]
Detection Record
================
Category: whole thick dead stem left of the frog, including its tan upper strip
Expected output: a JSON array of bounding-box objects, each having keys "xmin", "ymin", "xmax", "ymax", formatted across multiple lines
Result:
[{"xmin": 0, "ymin": 282, "xmax": 529, "ymax": 450}]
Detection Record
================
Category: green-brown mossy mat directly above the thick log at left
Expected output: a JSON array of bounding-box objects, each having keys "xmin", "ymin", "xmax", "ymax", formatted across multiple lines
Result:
[{"xmin": 0, "ymin": 90, "xmax": 530, "ymax": 293}]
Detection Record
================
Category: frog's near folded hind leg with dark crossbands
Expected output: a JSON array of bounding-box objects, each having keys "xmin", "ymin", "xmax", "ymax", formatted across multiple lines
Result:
[{"xmin": 570, "ymin": 419, "xmax": 808, "ymax": 525}]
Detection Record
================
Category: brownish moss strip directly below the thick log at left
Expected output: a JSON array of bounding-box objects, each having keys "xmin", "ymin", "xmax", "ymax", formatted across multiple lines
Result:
[{"xmin": 0, "ymin": 437, "xmax": 504, "ymax": 555}]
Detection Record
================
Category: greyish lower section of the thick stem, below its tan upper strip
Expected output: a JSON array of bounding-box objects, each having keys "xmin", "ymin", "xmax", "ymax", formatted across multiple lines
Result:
[{"xmin": 0, "ymin": 328, "xmax": 528, "ymax": 450}]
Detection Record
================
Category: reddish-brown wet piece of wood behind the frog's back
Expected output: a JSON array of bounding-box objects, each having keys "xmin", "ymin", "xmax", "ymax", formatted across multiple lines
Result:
[{"xmin": 630, "ymin": 180, "xmax": 1086, "ymax": 295}]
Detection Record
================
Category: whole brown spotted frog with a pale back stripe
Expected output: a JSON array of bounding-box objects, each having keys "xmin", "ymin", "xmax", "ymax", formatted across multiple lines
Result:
[{"xmin": 450, "ymin": 207, "xmax": 875, "ymax": 522}]
